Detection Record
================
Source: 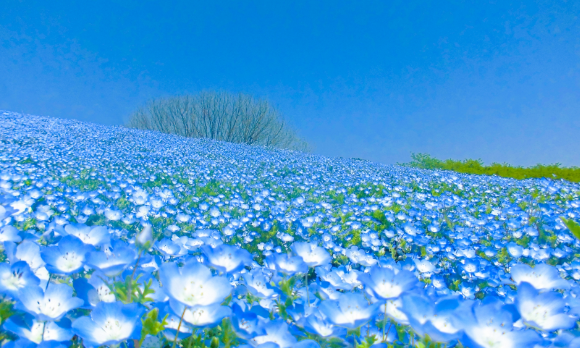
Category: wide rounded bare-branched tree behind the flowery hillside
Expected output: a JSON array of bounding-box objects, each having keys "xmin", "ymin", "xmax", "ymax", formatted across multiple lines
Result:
[{"xmin": 127, "ymin": 91, "xmax": 308, "ymax": 151}]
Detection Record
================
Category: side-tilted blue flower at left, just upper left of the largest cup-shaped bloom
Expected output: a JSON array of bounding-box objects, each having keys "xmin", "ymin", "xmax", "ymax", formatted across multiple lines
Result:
[{"xmin": 86, "ymin": 240, "xmax": 137, "ymax": 277}]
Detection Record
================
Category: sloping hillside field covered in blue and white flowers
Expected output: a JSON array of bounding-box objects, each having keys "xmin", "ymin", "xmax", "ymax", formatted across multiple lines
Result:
[{"xmin": 0, "ymin": 112, "xmax": 580, "ymax": 348}]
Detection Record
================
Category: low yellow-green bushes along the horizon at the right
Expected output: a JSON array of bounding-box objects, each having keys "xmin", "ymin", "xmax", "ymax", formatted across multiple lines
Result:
[{"xmin": 402, "ymin": 153, "xmax": 580, "ymax": 182}]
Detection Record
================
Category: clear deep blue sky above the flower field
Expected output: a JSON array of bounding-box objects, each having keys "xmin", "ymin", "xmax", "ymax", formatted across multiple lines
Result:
[{"xmin": 0, "ymin": 0, "xmax": 580, "ymax": 166}]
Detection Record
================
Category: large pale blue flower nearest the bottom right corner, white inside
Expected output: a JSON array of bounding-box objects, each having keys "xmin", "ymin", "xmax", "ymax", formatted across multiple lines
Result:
[{"xmin": 516, "ymin": 283, "xmax": 576, "ymax": 331}]
